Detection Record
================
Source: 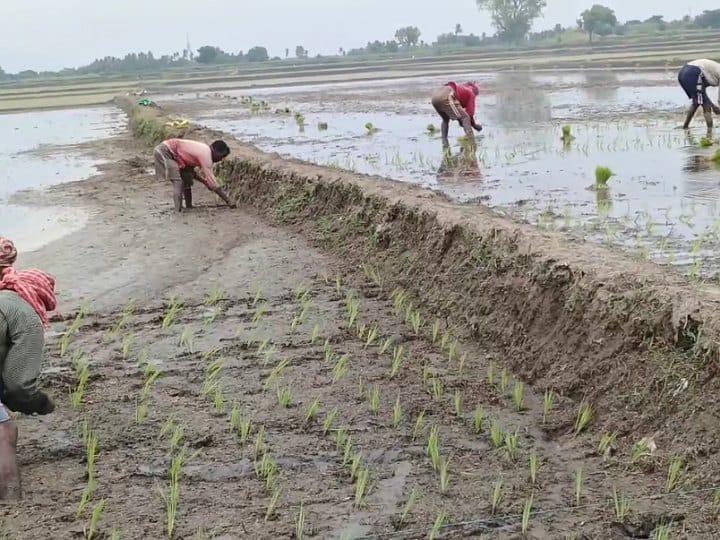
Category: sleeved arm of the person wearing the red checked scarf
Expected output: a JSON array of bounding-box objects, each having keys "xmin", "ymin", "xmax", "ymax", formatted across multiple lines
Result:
[{"xmin": 0, "ymin": 310, "xmax": 55, "ymax": 414}]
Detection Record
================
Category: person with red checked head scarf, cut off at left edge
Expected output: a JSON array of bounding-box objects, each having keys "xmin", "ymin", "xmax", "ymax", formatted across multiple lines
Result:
[{"xmin": 0, "ymin": 237, "xmax": 56, "ymax": 498}]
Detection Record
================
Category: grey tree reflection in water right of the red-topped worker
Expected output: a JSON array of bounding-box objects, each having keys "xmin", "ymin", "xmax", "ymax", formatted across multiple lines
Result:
[{"xmin": 494, "ymin": 71, "xmax": 552, "ymax": 125}]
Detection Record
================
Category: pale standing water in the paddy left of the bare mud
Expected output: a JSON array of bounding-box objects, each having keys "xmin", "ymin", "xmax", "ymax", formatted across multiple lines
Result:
[{"xmin": 0, "ymin": 108, "xmax": 123, "ymax": 251}]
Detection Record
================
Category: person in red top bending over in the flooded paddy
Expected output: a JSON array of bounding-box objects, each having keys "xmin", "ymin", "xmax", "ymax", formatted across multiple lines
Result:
[{"xmin": 431, "ymin": 82, "xmax": 482, "ymax": 148}]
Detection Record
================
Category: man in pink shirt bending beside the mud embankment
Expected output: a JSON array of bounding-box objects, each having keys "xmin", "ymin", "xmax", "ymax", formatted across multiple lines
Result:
[{"xmin": 153, "ymin": 139, "xmax": 235, "ymax": 212}]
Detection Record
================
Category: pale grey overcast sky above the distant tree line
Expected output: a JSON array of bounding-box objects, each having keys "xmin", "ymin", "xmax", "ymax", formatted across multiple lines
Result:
[{"xmin": 0, "ymin": 0, "xmax": 718, "ymax": 72}]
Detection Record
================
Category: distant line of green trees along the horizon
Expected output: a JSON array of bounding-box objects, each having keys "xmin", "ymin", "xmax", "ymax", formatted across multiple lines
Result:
[{"xmin": 0, "ymin": 6, "xmax": 720, "ymax": 80}]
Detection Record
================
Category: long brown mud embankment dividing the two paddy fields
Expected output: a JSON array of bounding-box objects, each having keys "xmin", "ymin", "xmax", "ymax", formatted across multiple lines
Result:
[{"xmin": 118, "ymin": 96, "xmax": 720, "ymax": 442}]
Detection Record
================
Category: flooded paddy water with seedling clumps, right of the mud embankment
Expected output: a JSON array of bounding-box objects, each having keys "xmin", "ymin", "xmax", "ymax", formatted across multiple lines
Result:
[{"xmin": 170, "ymin": 71, "xmax": 720, "ymax": 277}]
